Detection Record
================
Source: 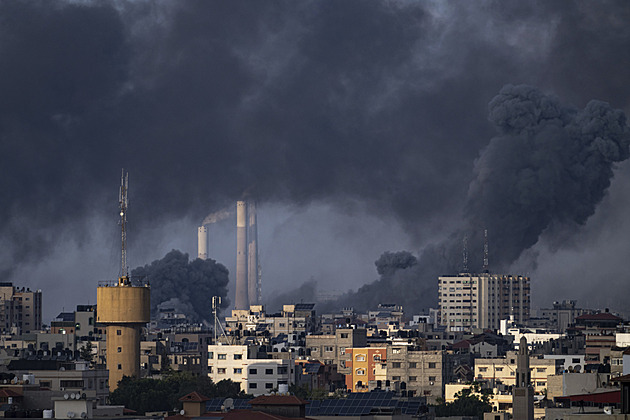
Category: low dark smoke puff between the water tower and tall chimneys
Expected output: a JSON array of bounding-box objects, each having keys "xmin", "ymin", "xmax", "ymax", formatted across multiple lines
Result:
[{"xmin": 131, "ymin": 250, "xmax": 230, "ymax": 322}]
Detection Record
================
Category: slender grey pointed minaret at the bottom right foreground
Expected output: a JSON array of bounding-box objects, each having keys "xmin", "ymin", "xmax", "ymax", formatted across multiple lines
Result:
[{"xmin": 512, "ymin": 337, "xmax": 534, "ymax": 420}]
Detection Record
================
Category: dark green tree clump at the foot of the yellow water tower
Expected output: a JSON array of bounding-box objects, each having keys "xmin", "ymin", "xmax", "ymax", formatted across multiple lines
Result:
[{"xmin": 110, "ymin": 372, "xmax": 246, "ymax": 413}]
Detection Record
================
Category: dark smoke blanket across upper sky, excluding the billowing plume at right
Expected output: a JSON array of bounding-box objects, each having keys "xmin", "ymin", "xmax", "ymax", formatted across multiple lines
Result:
[{"xmin": 0, "ymin": 0, "xmax": 630, "ymax": 318}]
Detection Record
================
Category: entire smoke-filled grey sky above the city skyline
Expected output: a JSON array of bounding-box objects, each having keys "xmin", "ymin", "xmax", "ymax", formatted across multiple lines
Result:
[{"xmin": 0, "ymin": 0, "xmax": 630, "ymax": 319}]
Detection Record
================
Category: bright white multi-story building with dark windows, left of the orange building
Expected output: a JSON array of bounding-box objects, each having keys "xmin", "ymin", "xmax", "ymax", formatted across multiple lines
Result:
[{"xmin": 208, "ymin": 345, "xmax": 295, "ymax": 395}]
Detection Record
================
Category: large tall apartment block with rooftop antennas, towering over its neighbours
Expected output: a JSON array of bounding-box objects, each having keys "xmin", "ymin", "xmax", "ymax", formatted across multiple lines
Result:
[{"xmin": 438, "ymin": 273, "xmax": 530, "ymax": 331}]
